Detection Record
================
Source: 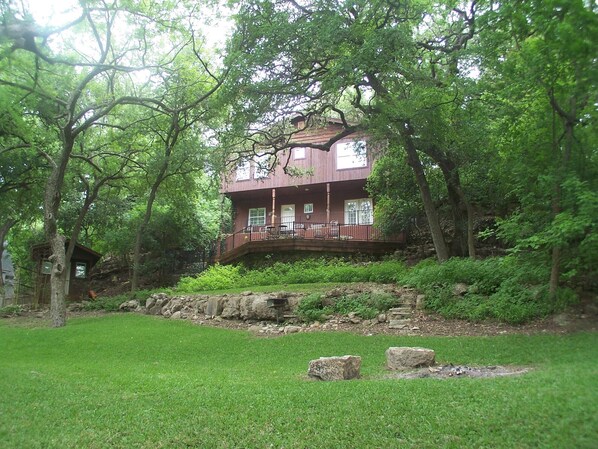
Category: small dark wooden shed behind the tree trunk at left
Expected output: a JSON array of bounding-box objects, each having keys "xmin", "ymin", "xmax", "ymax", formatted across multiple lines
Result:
[{"xmin": 31, "ymin": 240, "xmax": 102, "ymax": 304}]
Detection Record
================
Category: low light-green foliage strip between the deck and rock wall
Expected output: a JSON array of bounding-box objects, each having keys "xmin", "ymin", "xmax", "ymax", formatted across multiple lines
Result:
[{"xmin": 176, "ymin": 259, "xmax": 405, "ymax": 292}]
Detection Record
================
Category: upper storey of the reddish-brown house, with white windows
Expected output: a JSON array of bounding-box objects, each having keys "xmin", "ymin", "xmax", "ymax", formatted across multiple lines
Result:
[{"xmin": 222, "ymin": 118, "xmax": 373, "ymax": 193}]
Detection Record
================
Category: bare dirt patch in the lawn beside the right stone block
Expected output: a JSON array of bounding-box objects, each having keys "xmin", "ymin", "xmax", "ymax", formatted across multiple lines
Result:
[{"xmin": 384, "ymin": 365, "xmax": 530, "ymax": 379}]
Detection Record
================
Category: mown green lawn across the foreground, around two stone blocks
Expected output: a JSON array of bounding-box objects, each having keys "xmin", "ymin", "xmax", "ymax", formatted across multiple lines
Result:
[{"xmin": 0, "ymin": 314, "xmax": 598, "ymax": 449}]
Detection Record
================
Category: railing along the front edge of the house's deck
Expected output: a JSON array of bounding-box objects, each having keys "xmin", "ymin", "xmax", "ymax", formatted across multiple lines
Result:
[{"xmin": 221, "ymin": 221, "xmax": 403, "ymax": 254}]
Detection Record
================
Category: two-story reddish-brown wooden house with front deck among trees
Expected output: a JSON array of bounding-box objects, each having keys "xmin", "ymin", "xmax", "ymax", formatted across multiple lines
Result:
[{"xmin": 218, "ymin": 119, "xmax": 403, "ymax": 263}]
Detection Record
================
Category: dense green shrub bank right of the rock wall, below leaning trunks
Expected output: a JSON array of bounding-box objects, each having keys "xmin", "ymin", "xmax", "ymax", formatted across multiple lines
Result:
[{"xmin": 403, "ymin": 256, "xmax": 576, "ymax": 323}]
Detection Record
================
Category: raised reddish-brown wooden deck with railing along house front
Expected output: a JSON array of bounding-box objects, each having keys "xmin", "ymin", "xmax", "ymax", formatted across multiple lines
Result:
[{"xmin": 218, "ymin": 223, "xmax": 404, "ymax": 264}]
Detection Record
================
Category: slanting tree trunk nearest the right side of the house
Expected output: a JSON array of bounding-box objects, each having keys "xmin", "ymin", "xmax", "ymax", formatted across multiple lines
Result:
[{"xmin": 403, "ymin": 133, "xmax": 449, "ymax": 262}]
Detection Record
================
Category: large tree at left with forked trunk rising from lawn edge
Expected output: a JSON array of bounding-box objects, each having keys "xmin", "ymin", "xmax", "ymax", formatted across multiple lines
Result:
[{"xmin": 0, "ymin": 1, "xmax": 220, "ymax": 326}]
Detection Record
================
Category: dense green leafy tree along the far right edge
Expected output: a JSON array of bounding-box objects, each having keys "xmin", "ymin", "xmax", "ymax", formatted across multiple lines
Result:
[{"xmin": 483, "ymin": 1, "xmax": 598, "ymax": 299}]
